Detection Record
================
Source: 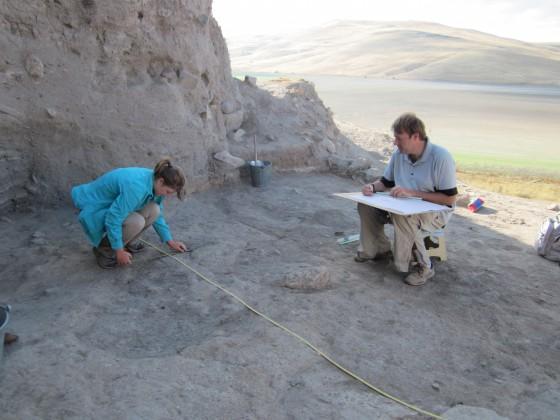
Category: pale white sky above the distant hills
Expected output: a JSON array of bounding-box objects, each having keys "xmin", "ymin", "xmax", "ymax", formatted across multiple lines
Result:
[{"xmin": 212, "ymin": 0, "xmax": 560, "ymax": 42}]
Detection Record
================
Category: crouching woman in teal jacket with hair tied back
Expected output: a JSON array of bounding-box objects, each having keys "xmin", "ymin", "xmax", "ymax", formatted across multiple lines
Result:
[{"xmin": 72, "ymin": 159, "xmax": 187, "ymax": 268}]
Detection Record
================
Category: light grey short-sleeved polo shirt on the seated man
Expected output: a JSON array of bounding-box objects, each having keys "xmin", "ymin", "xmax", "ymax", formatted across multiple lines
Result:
[{"xmin": 383, "ymin": 141, "xmax": 457, "ymax": 192}]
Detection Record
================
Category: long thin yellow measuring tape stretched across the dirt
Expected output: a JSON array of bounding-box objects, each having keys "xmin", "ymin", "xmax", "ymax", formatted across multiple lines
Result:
[{"xmin": 140, "ymin": 239, "xmax": 443, "ymax": 420}]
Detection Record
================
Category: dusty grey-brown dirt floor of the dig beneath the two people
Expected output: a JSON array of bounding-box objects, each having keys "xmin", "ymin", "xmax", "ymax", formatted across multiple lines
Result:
[{"xmin": 0, "ymin": 173, "xmax": 560, "ymax": 420}]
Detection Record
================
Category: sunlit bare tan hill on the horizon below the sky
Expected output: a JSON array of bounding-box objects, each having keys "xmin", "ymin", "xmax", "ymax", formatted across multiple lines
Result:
[{"xmin": 227, "ymin": 21, "xmax": 560, "ymax": 85}]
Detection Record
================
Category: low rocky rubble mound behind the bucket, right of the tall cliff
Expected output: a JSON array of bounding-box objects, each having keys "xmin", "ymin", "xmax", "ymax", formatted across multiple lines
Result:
[{"xmin": 226, "ymin": 78, "xmax": 369, "ymax": 170}]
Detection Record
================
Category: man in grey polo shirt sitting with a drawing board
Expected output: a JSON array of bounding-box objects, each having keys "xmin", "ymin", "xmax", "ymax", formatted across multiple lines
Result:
[{"xmin": 355, "ymin": 113, "xmax": 457, "ymax": 286}]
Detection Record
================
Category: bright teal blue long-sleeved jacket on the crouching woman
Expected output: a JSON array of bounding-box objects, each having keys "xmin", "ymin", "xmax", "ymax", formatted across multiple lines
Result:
[{"xmin": 72, "ymin": 168, "xmax": 172, "ymax": 249}]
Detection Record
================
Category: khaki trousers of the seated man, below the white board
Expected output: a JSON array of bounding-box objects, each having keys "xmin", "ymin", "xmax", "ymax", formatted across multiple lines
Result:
[{"xmin": 358, "ymin": 203, "xmax": 451, "ymax": 272}]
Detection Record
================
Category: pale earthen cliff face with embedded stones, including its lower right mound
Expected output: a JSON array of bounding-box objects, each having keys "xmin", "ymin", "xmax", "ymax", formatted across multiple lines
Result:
[{"xmin": 0, "ymin": 0, "xmax": 376, "ymax": 209}]
